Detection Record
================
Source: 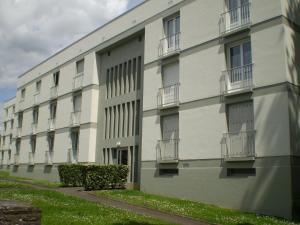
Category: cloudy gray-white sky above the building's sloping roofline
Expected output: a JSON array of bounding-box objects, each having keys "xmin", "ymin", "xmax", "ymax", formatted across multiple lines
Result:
[{"xmin": 0, "ymin": 0, "xmax": 143, "ymax": 126}]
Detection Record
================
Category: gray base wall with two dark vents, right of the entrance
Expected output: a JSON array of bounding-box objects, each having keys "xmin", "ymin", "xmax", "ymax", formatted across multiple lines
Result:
[{"xmin": 141, "ymin": 157, "xmax": 292, "ymax": 219}]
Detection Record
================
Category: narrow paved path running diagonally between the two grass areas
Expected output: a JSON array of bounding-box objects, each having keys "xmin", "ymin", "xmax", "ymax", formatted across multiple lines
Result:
[{"xmin": 1, "ymin": 179, "xmax": 211, "ymax": 225}]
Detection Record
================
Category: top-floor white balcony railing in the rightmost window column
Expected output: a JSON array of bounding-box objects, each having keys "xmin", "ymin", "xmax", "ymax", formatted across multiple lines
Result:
[{"xmin": 220, "ymin": 3, "xmax": 251, "ymax": 35}]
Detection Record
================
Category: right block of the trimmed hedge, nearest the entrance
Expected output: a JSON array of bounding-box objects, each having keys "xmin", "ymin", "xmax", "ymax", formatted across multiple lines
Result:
[{"xmin": 84, "ymin": 165, "xmax": 128, "ymax": 190}]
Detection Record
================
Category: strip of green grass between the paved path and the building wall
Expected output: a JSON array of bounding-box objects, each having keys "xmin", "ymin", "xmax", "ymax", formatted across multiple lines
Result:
[{"xmin": 93, "ymin": 190, "xmax": 296, "ymax": 225}]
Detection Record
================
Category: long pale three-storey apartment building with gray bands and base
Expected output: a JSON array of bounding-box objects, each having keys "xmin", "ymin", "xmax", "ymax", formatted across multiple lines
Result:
[{"xmin": 1, "ymin": 0, "xmax": 300, "ymax": 218}]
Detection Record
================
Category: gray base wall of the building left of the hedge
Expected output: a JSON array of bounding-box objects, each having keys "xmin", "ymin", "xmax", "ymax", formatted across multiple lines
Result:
[{"xmin": 0, "ymin": 164, "xmax": 59, "ymax": 182}]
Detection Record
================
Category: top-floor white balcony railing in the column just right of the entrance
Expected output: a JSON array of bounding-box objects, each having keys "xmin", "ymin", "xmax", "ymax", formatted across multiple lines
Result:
[{"xmin": 158, "ymin": 33, "xmax": 180, "ymax": 57}]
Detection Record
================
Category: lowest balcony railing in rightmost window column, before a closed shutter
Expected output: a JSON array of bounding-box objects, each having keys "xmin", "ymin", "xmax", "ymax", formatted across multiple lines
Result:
[{"xmin": 222, "ymin": 130, "xmax": 255, "ymax": 161}]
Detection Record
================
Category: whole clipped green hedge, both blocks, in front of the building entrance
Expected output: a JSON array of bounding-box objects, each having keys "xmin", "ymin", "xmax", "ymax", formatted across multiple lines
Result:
[{"xmin": 58, "ymin": 164, "xmax": 128, "ymax": 190}]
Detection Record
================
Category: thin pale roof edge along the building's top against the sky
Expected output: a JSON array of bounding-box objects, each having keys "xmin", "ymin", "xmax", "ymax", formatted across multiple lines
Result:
[{"xmin": 17, "ymin": 0, "xmax": 150, "ymax": 79}]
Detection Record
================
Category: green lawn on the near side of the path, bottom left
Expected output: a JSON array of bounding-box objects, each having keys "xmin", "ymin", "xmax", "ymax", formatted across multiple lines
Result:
[{"xmin": 0, "ymin": 181, "xmax": 173, "ymax": 225}]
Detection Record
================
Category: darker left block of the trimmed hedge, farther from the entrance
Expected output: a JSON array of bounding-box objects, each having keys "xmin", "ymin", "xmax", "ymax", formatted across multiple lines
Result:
[{"xmin": 58, "ymin": 164, "xmax": 86, "ymax": 187}]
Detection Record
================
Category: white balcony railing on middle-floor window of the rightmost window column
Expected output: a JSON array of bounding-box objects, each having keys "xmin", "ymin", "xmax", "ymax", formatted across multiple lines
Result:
[{"xmin": 222, "ymin": 64, "xmax": 253, "ymax": 95}]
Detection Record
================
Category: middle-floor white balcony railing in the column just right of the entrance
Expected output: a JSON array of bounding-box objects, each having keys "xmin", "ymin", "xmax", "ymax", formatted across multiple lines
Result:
[{"xmin": 157, "ymin": 83, "xmax": 179, "ymax": 108}]
